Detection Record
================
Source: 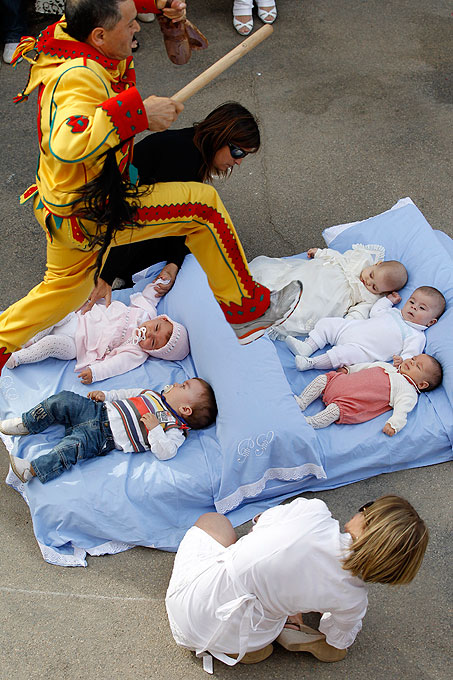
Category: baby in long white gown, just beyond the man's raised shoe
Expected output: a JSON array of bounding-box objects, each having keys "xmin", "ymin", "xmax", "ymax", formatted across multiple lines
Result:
[{"xmin": 249, "ymin": 243, "xmax": 407, "ymax": 337}]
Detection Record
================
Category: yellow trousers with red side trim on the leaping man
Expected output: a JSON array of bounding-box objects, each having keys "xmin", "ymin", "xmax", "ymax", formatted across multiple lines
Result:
[{"xmin": 0, "ymin": 182, "xmax": 270, "ymax": 370}]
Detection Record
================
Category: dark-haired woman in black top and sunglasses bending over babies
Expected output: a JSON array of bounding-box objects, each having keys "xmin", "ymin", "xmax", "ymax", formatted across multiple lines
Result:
[{"xmin": 83, "ymin": 102, "xmax": 261, "ymax": 311}]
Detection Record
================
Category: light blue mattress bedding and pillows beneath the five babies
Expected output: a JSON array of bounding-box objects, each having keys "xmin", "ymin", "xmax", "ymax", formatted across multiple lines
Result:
[{"xmin": 0, "ymin": 203, "xmax": 453, "ymax": 566}]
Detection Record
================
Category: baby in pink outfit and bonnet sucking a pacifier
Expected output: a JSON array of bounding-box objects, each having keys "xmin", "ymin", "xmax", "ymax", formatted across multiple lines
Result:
[{"xmin": 6, "ymin": 279, "xmax": 190, "ymax": 385}]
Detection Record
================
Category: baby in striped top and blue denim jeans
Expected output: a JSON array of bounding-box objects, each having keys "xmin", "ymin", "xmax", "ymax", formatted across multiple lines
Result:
[{"xmin": 0, "ymin": 378, "xmax": 217, "ymax": 484}]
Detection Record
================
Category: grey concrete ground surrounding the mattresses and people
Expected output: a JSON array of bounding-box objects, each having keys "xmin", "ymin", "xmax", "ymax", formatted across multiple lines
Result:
[{"xmin": 0, "ymin": 0, "xmax": 453, "ymax": 680}]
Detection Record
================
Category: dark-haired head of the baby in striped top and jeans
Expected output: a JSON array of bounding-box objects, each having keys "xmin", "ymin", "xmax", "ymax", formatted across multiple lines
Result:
[{"xmin": 164, "ymin": 378, "xmax": 217, "ymax": 430}]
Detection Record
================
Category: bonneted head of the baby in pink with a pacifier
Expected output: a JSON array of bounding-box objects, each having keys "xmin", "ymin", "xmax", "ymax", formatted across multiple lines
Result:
[{"xmin": 137, "ymin": 314, "xmax": 190, "ymax": 361}]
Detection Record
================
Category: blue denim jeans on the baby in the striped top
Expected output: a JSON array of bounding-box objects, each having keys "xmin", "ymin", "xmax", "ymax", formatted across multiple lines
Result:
[{"xmin": 22, "ymin": 392, "xmax": 115, "ymax": 484}]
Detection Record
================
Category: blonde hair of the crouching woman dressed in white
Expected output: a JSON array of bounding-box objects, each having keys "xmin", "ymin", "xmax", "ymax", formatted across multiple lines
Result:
[{"xmin": 343, "ymin": 496, "xmax": 428, "ymax": 585}]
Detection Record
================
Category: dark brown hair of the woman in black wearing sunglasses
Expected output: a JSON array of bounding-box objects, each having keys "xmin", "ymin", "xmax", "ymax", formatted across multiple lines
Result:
[{"xmin": 193, "ymin": 102, "xmax": 260, "ymax": 182}]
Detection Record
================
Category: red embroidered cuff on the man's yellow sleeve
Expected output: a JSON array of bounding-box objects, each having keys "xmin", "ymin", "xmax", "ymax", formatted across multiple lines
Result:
[{"xmin": 101, "ymin": 87, "xmax": 148, "ymax": 140}]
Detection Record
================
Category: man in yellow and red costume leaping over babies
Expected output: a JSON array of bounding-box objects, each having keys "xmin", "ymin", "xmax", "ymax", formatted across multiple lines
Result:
[{"xmin": 0, "ymin": 0, "xmax": 301, "ymax": 378}]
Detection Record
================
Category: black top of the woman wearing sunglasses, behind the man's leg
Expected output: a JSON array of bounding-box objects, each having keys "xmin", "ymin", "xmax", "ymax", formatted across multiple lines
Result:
[{"xmin": 100, "ymin": 127, "xmax": 203, "ymax": 287}]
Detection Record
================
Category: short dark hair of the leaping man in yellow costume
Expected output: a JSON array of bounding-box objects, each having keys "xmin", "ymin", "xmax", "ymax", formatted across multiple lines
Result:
[{"xmin": 65, "ymin": 0, "xmax": 123, "ymax": 42}]
